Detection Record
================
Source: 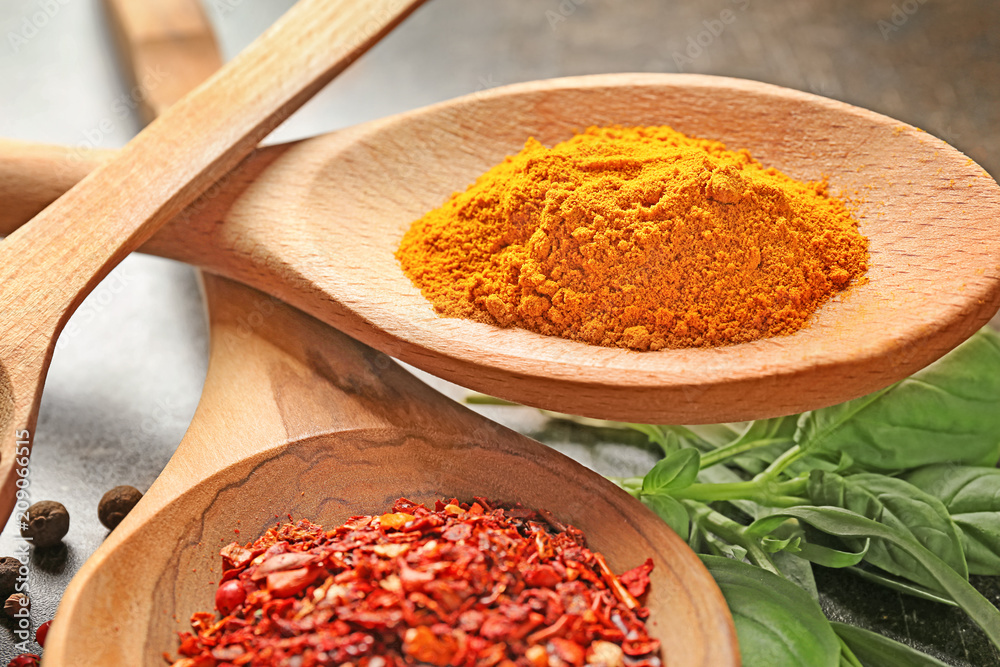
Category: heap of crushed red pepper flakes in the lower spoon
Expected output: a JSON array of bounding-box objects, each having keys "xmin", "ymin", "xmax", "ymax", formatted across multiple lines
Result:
[{"xmin": 164, "ymin": 498, "xmax": 661, "ymax": 667}]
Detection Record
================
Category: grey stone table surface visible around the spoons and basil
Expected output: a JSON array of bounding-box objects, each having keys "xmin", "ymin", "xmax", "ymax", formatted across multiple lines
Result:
[{"xmin": 0, "ymin": 0, "xmax": 1000, "ymax": 666}]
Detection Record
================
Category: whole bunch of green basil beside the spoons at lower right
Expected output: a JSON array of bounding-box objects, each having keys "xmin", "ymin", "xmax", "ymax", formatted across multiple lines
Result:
[{"xmin": 618, "ymin": 329, "xmax": 1000, "ymax": 667}]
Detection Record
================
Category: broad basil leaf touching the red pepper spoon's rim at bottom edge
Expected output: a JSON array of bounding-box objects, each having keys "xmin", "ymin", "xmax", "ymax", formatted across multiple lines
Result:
[{"xmin": 701, "ymin": 556, "xmax": 840, "ymax": 667}]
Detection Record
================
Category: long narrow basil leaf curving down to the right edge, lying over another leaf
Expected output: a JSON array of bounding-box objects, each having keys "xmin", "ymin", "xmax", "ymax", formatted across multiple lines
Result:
[{"xmin": 752, "ymin": 507, "xmax": 1000, "ymax": 647}]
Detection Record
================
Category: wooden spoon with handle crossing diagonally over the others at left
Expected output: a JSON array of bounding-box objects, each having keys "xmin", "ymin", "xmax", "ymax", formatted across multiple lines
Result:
[{"xmin": 0, "ymin": 0, "xmax": 422, "ymax": 528}]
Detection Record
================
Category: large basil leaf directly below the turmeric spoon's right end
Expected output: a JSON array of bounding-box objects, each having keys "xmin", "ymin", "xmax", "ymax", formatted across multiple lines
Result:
[{"xmin": 795, "ymin": 329, "xmax": 1000, "ymax": 471}]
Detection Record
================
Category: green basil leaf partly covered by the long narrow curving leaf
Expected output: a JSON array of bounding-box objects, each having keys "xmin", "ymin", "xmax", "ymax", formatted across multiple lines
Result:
[{"xmin": 807, "ymin": 470, "xmax": 969, "ymax": 586}]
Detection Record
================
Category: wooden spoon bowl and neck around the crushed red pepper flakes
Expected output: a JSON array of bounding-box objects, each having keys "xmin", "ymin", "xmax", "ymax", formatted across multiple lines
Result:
[{"xmin": 44, "ymin": 276, "xmax": 739, "ymax": 667}]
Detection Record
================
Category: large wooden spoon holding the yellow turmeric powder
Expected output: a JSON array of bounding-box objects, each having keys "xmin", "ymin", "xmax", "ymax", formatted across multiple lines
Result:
[{"xmin": 0, "ymin": 74, "xmax": 1000, "ymax": 423}]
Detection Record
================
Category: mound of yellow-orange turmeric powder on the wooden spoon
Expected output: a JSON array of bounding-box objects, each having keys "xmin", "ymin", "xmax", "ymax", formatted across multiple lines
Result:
[{"xmin": 396, "ymin": 127, "xmax": 868, "ymax": 350}]
